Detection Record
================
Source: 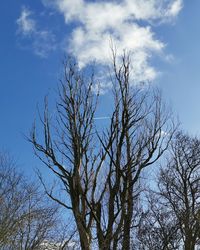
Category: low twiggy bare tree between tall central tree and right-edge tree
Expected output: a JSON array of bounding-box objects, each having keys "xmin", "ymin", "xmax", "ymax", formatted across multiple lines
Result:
[{"xmin": 137, "ymin": 192, "xmax": 181, "ymax": 250}]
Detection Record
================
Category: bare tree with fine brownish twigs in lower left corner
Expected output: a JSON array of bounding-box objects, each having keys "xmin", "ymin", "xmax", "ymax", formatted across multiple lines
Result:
[{"xmin": 0, "ymin": 153, "xmax": 63, "ymax": 250}]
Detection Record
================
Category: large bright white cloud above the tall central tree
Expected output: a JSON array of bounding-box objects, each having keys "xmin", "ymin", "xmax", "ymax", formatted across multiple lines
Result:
[{"xmin": 43, "ymin": 0, "xmax": 183, "ymax": 81}]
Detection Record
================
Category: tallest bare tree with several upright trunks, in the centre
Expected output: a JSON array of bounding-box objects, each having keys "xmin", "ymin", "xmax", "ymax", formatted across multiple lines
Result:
[{"xmin": 30, "ymin": 54, "xmax": 174, "ymax": 250}]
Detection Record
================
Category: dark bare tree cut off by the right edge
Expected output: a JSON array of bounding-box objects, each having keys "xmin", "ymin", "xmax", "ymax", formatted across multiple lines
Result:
[{"xmin": 141, "ymin": 132, "xmax": 200, "ymax": 250}]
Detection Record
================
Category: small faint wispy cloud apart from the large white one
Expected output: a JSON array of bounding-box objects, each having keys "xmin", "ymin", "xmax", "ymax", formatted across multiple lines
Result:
[{"xmin": 16, "ymin": 7, "xmax": 56, "ymax": 57}]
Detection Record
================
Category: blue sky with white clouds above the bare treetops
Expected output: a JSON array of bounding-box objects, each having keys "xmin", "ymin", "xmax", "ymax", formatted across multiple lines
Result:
[{"xmin": 0, "ymin": 0, "xmax": 200, "ymax": 172}]
